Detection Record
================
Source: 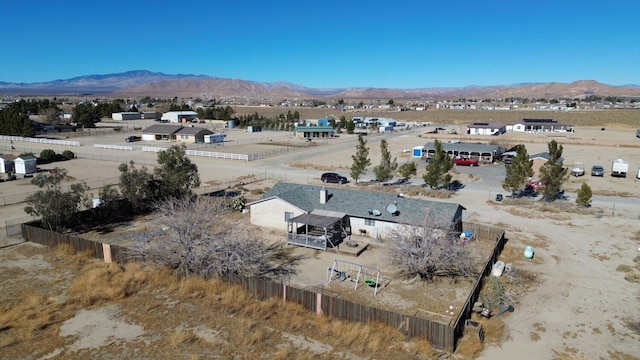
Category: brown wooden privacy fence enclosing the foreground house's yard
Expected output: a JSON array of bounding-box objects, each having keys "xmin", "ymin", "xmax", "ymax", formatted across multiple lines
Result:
[{"xmin": 22, "ymin": 223, "xmax": 506, "ymax": 353}]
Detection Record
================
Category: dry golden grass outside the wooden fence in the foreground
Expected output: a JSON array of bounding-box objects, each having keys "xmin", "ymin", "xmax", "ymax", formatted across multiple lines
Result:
[{"xmin": 0, "ymin": 245, "xmax": 444, "ymax": 359}]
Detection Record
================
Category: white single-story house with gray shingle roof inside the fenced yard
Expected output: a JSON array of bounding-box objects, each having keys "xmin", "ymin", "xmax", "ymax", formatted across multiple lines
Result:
[{"xmin": 247, "ymin": 182, "xmax": 464, "ymax": 249}]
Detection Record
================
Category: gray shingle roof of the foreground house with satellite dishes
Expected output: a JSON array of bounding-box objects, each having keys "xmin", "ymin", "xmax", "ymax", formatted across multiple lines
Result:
[{"xmin": 262, "ymin": 182, "xmax": 464, "ymax": 225}]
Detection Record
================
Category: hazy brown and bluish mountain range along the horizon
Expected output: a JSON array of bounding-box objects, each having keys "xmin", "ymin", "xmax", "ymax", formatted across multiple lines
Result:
[{"xmin": 0, "ymin": 70, "xmax": 640, "ymax": 100}]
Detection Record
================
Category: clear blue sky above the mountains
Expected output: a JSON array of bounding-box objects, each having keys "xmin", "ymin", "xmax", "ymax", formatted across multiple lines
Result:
[{"xmin": 0, "ymin": 0, "xmax": 640, "ymax": 88}]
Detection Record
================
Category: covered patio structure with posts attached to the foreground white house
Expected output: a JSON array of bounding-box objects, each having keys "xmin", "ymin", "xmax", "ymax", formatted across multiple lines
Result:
[{"xmin": 287, "ymin": 209, "xmax": 351, "ymax": 251}]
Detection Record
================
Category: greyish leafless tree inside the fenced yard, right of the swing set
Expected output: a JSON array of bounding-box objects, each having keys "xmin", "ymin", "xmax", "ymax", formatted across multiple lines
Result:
[{"xmin": 387, "ymin": 211, "xmax": 478, "ymax": 280}]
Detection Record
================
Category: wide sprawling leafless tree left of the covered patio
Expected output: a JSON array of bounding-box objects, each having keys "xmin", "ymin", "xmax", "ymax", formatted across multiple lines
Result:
[{"xmin": 128, "ymin": 197, "xmax": 300, "ymax": 279}]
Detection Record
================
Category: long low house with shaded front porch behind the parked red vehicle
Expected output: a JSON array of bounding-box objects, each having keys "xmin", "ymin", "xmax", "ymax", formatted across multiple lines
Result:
[{"xmin": 411, "ymin": 142, "xmax": 504, "ymax": 163}]
